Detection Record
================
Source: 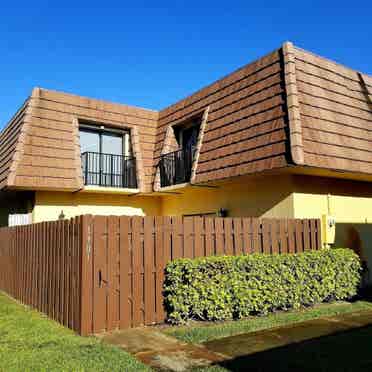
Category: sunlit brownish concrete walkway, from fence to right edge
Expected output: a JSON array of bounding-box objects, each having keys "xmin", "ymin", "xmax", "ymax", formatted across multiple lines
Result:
[{"xmin": 103, "ymin": 311, "xmax": 372, "ymax": 372}]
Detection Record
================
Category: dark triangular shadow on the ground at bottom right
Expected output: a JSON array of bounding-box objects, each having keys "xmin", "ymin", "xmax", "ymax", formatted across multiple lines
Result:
[{"xmin": 219, "ymin": 325, "xmax": 372, "ymax": 372}]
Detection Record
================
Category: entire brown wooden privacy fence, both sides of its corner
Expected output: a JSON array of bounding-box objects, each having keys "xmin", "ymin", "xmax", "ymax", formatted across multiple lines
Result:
[{"xmin": 0, "ymin": 216, "xmax": 321, "ymax": 335}]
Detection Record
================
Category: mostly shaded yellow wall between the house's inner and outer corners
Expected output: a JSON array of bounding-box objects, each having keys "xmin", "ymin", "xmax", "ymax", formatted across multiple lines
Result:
[{"xmin": 162, "ymin": 175, "xmax": 293, "ymax": 218}]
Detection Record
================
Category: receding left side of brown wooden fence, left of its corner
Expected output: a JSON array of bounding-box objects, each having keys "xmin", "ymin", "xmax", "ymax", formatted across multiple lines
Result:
[{"xmin": 0, "ymin": 217, "xmax": 82, "ymax": 331}]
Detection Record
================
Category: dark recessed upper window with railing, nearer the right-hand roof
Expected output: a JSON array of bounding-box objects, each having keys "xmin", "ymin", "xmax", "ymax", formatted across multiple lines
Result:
[{"xmin": 159, "ymin": 116, "xmax": 201, "ymax": 187}]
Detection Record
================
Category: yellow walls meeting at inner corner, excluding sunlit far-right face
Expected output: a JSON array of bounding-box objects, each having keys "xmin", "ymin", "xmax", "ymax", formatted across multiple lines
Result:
[{"xmin": 33, "ymin": 175, "xmax": 293, "ymax": 222}]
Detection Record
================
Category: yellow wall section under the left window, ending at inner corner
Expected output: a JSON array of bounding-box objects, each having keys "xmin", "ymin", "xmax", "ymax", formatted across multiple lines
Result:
[{"xmin": 33, "ymin": 192, "xmax": 161, "ymax": 223}]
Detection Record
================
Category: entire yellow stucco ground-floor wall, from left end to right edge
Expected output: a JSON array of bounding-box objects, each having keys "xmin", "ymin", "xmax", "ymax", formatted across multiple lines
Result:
[{"xmin": 33, "ymin": 174, "xmax": 372, "ymax": 223}]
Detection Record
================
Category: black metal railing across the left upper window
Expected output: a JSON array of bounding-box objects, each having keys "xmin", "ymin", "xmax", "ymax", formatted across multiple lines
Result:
[{"xmin": 81, "ymin": 152, "xmax": 137, "ymax": 189}]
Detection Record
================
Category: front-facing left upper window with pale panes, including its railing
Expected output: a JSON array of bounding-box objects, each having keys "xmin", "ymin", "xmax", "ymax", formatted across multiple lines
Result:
[{"xmin": 80, "ymin": 125, "xmax": 137, "ymax": 188}]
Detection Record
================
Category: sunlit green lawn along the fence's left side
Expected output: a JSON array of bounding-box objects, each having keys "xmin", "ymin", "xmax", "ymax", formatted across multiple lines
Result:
[{"xmin": 0, "ymin": 293, "xmax": 150, "ymax": 372}]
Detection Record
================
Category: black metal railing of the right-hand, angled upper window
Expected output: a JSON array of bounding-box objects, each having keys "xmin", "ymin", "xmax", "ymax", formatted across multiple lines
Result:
[{"xmin": 159, "ymin": 147, "xmax": 195, "ymax": 187}]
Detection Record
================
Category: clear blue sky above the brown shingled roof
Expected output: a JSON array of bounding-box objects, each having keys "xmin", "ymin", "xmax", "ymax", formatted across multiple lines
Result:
[{"xmin": 0, "ymin": 0, "xmax": 372, "ymax": 128}]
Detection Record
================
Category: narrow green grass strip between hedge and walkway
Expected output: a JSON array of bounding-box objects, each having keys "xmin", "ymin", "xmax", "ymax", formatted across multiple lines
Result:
[{"xmin": 163, "ymin": 301, "xmax": 372, "ymax": 343}]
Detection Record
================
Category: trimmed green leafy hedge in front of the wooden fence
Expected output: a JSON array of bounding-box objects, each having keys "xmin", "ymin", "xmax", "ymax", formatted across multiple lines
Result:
[{"xmin": 164, "ymin": 248, "xmax": 361, "ymax": 323}]
